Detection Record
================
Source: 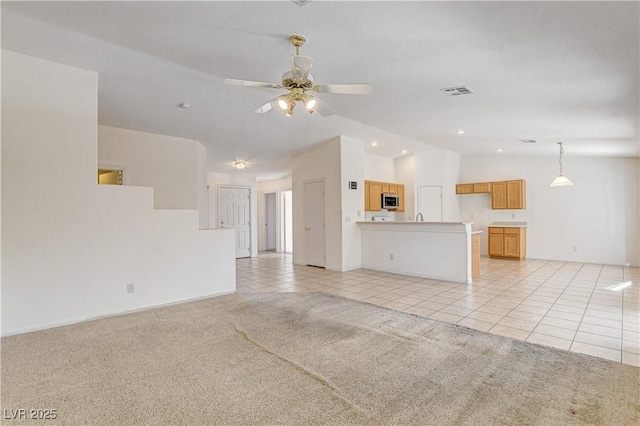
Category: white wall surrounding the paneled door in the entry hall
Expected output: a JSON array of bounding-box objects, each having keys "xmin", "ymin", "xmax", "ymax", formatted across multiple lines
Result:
[{"xmin": 207, "ymin": 170, "xmax": 258, "ymax": 257}]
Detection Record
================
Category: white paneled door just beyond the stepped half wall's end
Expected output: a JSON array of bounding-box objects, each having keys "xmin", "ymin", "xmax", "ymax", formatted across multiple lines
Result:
[{"xmin": 220, "ymin": 187, "xmax": 251, "ymax": 258}]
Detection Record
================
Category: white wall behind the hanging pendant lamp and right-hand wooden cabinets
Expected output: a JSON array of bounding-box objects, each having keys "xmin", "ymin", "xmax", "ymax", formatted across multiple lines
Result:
[{"xmin": 458, "ymin": 155, "xmax": 640, "ymax": 266}]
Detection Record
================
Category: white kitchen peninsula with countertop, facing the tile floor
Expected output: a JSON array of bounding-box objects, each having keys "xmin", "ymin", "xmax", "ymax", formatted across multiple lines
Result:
[{"xmin": 358, "ymin": 221, "xmax": 482, "ymax": 284}]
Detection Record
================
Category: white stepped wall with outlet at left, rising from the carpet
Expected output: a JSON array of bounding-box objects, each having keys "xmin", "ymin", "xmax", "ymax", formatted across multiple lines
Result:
[{"xmin": 1, "ymin": 51, "xmax": 235, "ymax": 335}]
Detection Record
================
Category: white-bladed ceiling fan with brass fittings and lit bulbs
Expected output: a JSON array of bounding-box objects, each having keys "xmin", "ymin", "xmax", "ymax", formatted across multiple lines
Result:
[{"xmin": 223, "ymin": 35, "xmax": 371, "ymax": 117}]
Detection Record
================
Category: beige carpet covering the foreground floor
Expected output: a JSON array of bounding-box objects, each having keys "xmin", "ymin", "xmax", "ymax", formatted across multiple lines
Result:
[{"xmin": 1, "ymin": 293, "xmax": 640, "ymax": 425}]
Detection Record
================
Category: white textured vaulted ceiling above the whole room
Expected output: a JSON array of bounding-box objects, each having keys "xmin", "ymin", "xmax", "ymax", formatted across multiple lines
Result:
[{"xmin": 1, "ymin": 1, "xmax": 640, "ymax": 178}]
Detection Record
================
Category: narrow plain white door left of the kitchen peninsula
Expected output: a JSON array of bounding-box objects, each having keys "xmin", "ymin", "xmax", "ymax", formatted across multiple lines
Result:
[{"xmin": 304, "ymin": 181, "xmax": 327, "ymax": 268}]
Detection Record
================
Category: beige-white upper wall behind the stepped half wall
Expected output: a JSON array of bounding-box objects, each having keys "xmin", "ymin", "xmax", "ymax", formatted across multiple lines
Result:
[{"xmin": 98, "ymin": 126, "xmax": 207, "ymax": 228}]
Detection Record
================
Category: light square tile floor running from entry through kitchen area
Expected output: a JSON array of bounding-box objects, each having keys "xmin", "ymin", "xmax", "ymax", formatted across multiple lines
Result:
[{"xmin": 236, "ymin": 252, "xmax": 640, "ymax": 367}]
